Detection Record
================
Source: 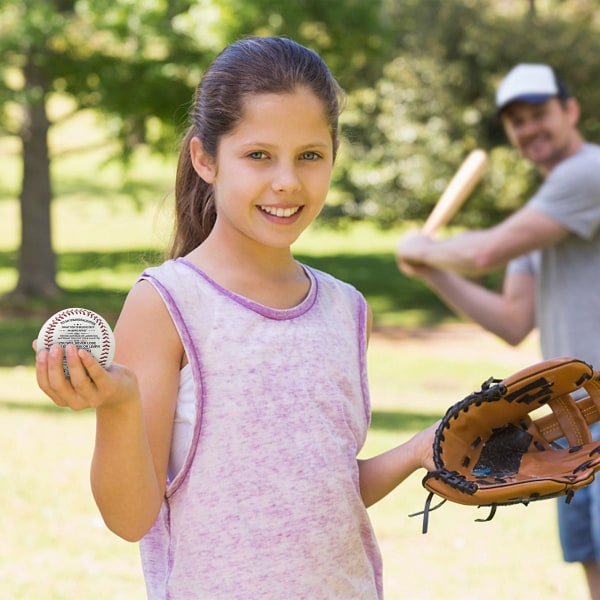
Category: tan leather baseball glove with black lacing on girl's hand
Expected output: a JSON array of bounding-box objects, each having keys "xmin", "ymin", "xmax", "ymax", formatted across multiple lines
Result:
[{"xmin": 413, "ymin": 357, "xmax": 600, "ymax": 533}]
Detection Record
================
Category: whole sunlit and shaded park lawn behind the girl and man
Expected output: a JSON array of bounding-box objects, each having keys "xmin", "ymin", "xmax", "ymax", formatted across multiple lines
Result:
[{"xmin": 0, "ymin": 138, "xmax": 586, "ymax": 600}]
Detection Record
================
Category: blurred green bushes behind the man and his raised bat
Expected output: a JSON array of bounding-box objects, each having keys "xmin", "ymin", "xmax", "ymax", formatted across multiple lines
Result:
[{"xmin": 333, "ymin": 0, "xmax": 600, "ymax": 227}]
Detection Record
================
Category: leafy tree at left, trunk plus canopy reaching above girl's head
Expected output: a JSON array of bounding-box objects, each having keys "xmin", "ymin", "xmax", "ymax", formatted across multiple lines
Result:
[{"xmin": 0, "ymin": 0, "xmax": 392, "ymax": 298}]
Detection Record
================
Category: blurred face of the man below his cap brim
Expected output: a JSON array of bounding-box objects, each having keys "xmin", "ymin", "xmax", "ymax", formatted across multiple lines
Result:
[{"xmin": 502, "ymin": 98, "xmax": 579, "ymax": 174}]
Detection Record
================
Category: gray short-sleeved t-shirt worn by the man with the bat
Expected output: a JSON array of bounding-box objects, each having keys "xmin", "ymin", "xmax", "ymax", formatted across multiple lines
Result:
[{"xmin": 508, "ymin": 144, "xmax": 600, "ymax": 369}]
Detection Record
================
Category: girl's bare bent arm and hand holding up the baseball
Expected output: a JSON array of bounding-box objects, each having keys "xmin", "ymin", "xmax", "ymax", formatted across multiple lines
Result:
[{"xmin": 36, "ymin": 282, "xmax": 183, "ymax": 541}]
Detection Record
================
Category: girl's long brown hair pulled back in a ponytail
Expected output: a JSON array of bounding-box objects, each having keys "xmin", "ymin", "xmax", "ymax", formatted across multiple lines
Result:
[{"xmin": 168, "ymin": 37, "xmax": 344, "ymax": 258}]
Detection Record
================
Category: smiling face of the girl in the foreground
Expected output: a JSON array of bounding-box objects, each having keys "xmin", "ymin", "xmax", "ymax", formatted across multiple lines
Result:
[{"xmin": 191, "ymin": 87, "xmax": 334, "ymax": 248}]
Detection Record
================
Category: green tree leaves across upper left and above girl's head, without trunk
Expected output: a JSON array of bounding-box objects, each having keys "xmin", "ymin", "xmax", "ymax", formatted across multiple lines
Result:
[{"xmin": 0, "ymin": 0, "xmax": 392, "ymax": 157}]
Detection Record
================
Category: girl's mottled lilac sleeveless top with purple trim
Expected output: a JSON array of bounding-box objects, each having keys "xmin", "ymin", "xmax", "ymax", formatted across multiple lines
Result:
[{"xmin": 140, "ymin": 259, "xmax": 383, "ymax": 600}]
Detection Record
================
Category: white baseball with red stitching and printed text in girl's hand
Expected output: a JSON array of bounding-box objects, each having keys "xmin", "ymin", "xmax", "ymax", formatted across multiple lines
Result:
[{"xmin": 37, "ymin": 308, "xmax": 115, "ymax": 377}]
